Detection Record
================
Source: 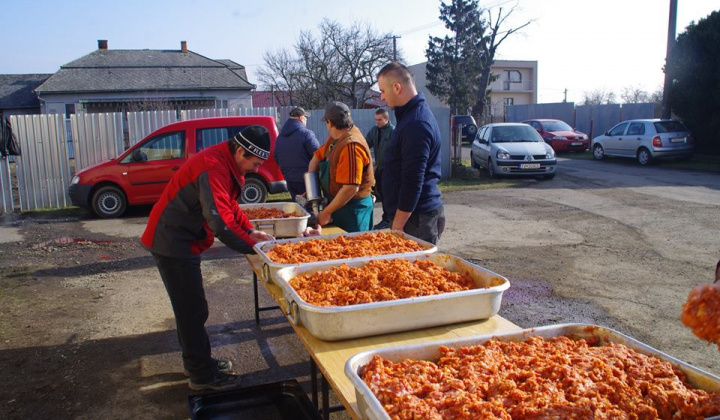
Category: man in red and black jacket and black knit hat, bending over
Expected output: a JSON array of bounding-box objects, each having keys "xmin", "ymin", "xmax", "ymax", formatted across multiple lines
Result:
[{"xmin": 141, "ymin": 125, "xmax": 273, "ymax": 391}]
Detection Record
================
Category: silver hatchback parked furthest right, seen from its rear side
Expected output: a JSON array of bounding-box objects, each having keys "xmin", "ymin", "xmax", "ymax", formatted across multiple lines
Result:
[{"xmin": 590, "ymin": 119, "xmax": 693, "ymax": 165}]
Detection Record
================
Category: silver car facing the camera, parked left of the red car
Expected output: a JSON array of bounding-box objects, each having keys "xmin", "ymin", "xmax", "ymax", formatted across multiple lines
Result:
[{"xmin": 470, "ymin": 123, "xmax": 557, "ymax": 179}]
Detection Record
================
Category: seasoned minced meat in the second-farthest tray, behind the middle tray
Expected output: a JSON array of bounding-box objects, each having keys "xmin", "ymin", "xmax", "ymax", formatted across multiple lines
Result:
[{"xmin": 267, "ymin": 232, "xmax": 425, "ymax": 264}]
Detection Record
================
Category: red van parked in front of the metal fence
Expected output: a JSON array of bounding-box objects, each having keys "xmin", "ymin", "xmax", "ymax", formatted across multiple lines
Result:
[{"xmin": 68, "ymin": 116, "xmax": 287, "ymax": 218}]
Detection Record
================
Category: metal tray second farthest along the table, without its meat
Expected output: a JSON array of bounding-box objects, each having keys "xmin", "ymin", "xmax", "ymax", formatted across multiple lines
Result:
[{"xmin": 253, "ymin": 230, "xmax": 437, "ymax": 284}]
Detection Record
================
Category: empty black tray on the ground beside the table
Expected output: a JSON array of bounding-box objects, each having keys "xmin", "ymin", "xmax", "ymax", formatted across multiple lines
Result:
[{"xmin": 188, "ymin": 379, "xmax": 321, "ymax": 420}]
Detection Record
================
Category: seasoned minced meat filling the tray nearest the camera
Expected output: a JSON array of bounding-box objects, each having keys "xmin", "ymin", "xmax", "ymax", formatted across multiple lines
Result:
[{"xmin": 360, "ymin": 337, "xmax": 720, "ymax": 420}]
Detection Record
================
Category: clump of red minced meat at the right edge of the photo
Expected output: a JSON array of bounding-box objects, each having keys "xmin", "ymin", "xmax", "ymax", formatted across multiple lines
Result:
[{"xmin": 680, "ymin": 284, "xmax": 720, "ymax": 350}]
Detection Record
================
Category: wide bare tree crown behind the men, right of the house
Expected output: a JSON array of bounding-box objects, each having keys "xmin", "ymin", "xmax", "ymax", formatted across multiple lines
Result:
[{"xmin": 258, "ymin": 19, "xmax": 402, "ymax": 108}]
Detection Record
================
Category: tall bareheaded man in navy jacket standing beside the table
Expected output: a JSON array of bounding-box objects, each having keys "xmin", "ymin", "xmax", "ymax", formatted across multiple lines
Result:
[{"xmin": 378, "ymin": 61, "xmax": 445, "ymax": 244}]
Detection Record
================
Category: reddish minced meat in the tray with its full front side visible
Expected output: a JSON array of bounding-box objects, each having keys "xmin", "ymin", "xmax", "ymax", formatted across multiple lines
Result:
[{"xmin": 290, "ymin": 258, "xmax": 486, "ymax": 306}]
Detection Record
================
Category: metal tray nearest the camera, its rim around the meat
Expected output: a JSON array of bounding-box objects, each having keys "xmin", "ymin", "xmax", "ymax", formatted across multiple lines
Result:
[{"xmin": 345, "ymin": 324, "xmax": 720, "ymax": 420}]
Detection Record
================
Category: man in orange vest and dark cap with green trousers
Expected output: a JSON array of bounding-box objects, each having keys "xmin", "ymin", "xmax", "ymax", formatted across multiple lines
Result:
[{"xmin": 308, "ymin": 102, "xmax": 375, "ymax": 232}]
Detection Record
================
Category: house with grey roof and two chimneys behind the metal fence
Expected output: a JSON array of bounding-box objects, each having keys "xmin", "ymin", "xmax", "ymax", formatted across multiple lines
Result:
[{"xmin": 35, "ymin": 40, "xmax": 255, "ymax": 115}]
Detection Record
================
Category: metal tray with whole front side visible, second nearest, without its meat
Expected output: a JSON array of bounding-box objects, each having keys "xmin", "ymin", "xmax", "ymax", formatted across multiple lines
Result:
[{"xmin": 277, "ymin": 254, "xmax": 510, "ymax": 341}]
